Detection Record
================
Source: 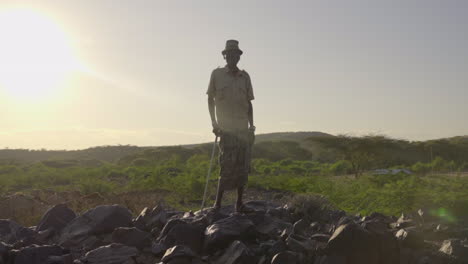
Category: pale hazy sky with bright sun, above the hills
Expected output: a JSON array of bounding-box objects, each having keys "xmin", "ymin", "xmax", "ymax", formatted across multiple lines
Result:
[{"xmin": 0, "ymin": 0, "xmax": 468, "ymax": 150}]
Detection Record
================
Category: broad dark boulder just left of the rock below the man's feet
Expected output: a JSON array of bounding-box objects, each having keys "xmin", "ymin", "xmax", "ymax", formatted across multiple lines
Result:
[{"xmin": 158, "ymin": 219, "xmax": 205, "ymax": 252}]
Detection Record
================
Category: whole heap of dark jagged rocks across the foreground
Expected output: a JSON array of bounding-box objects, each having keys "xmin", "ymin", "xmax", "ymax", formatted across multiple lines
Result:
[{"xmin": 0, "ymin": 196, "xmax": 468, "ymax": 264}]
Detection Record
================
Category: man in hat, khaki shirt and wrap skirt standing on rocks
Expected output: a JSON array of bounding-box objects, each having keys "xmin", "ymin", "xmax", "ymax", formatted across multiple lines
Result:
[{"xmin": 206, "ymin": 40, "xmax": 255, "ymax": 212}]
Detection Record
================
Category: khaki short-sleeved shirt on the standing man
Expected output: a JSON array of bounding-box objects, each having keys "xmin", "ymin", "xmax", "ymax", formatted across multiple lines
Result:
[{"xmin": 206, "ymin": 66, "xmax": 254, "ymax": 131}]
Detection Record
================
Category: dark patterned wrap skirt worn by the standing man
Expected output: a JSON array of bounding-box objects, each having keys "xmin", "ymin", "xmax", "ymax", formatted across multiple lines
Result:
[{"xmin": 218, "ymin": 130, "xmax": 255, "ymax": 190}]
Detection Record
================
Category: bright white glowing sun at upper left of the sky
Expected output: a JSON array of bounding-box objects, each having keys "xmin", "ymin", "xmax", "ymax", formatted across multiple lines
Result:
[{"xmin": 0, "ymin": 8, "xmax": 81, "ymax": 100}]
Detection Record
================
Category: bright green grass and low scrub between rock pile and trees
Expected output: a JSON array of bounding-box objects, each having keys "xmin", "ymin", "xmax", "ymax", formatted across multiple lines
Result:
[{"xmin": 0, "ymin": 155, "xmax": 468, "ymax": 225}]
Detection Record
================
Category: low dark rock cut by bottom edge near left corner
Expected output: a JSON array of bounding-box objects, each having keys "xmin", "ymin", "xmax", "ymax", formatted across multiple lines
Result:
[{"xmin": 14, "ymin": 245, "xmax": 68, "ymax": 264}]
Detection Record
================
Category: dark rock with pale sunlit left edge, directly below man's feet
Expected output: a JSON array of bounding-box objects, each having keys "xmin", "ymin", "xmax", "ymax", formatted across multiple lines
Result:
[{"xmin": 204, "ymin": 214, "xmax": 255, "ymax": 252}]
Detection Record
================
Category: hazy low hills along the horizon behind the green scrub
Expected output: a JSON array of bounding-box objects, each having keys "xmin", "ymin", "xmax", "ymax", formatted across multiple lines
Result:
[{"xmin": 0, "ymin": 131, "xmax": 468, "ymax": 167}]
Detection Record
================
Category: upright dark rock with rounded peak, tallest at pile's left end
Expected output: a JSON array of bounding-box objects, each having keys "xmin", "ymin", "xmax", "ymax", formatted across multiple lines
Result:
[{"xmin": 36, "ymin": 204, "xmax": 76, "ymax": 232}]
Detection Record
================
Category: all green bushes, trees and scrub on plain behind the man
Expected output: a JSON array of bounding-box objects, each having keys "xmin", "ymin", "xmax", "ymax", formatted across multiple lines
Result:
[{"xmin": 0, "ymin": 133, "xmax": 468, "ymax": 221}]
